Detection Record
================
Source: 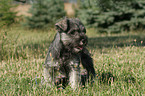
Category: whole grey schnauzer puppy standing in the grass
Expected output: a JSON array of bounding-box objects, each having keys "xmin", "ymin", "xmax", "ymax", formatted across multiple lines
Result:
[{"xmin": 44, "ymin": 18, "xmax": 95, "ymax": 89}]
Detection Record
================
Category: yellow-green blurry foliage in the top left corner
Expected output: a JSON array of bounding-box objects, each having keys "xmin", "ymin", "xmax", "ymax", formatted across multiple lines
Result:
[{"xmin": 0, "ymin": 0, "xmax": 17, "ymax": 27}]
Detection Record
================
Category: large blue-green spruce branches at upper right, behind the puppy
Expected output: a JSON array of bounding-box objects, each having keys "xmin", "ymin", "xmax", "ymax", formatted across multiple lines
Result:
[{"xmin": 77, "ymin": 0, "xmax": 145, "ymax": 33}]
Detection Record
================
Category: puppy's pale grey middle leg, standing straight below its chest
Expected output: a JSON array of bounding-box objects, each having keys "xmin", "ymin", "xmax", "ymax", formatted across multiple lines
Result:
[{"xmin": 69, "ymin": 60, "xmax": 81, "ymax": 89}]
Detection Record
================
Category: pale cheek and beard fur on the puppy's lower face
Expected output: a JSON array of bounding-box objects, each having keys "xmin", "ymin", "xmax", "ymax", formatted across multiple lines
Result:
[{"xmin": 61, "ymin": 33, "xmax": 84, "ymax": 53}]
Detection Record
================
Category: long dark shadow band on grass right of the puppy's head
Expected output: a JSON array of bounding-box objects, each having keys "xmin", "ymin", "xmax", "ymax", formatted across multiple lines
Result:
[{"xmin": 88, "ymin": 35, "xmax": 145, "ymax": 49}]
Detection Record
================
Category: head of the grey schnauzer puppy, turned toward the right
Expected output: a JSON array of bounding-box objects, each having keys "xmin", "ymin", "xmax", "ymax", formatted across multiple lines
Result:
[{"xmin": 55, "ymin": 18, "xmax": 88, "ymax": 53}]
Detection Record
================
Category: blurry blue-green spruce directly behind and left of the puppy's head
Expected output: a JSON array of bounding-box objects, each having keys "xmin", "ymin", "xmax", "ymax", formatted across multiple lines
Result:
[{"xmin": 25, "ymin": 0, "xmax": 65, "ymax": 29}]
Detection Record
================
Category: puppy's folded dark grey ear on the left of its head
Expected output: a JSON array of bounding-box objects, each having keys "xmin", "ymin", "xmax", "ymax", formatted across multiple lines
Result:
[{"xmin": 55, "ymin": 18, "xmax": 69, "ymax": 32}]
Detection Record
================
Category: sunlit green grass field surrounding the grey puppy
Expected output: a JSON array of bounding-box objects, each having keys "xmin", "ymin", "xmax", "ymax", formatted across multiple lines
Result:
[{"xmin": 0, "ymin": 27, "xmax": 145, "ymax": 96}]
